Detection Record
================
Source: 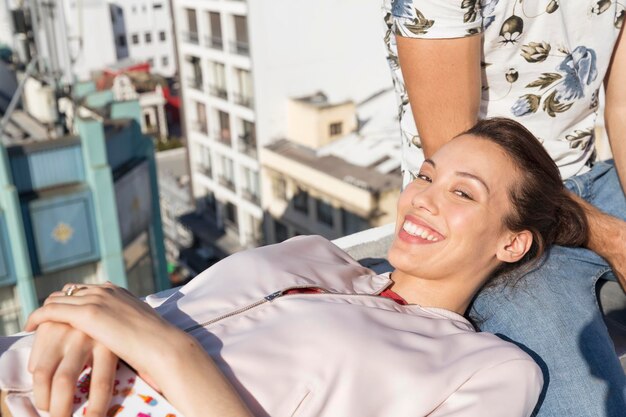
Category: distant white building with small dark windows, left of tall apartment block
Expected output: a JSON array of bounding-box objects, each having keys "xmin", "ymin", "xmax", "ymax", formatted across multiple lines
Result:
[{"xmin": 108, "ymin": 0, "xmax": 177, "ymax": 77}]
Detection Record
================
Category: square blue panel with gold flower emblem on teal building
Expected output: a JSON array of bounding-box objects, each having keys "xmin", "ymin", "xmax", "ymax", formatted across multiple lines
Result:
[{"xmin": 28, "ymin": 190, "xmax": 99, "ymax": 273}]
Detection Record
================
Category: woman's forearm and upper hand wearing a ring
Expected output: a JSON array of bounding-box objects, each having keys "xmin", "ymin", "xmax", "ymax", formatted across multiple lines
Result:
[{"xmin": 26, "ymin": 284, "xmax": 250, "ymax": 417}]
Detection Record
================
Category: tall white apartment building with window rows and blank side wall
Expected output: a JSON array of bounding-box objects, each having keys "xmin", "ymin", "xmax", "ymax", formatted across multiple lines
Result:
[{"xmin": 173, "ymin": 0, "xmax": 391, "ymax": 252}]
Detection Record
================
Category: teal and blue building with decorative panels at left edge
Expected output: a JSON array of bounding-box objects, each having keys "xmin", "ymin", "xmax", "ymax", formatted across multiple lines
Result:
[{"xmin": 0, "ymin": 83, "xmax": 169, "ymax": 334}]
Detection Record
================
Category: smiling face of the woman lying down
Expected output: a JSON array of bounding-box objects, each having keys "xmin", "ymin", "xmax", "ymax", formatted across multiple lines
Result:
[{"xmin": 389, "ymin": 135, "xmax": 518, "ymax": 279}]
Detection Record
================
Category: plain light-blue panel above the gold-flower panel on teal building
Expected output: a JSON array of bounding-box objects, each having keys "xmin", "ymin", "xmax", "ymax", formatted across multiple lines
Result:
[{"xmin": 11, "ymin": 144, "xmax": 85, "ymax": 193}]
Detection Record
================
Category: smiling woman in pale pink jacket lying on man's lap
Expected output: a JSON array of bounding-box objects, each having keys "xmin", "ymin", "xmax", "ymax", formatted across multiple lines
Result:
[{"xmin": 0, "ymin": 119, "xmax": 587, "ymax": 417}]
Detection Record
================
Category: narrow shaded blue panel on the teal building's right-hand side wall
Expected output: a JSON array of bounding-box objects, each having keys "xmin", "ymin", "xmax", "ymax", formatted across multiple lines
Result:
[{"xmin": 115, "ymin": 162, "xmax": 152, "ymax": 245}]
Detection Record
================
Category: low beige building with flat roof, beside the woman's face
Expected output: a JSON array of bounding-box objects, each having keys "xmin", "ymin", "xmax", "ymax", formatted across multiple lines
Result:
[{"xmin": 260, "ymin": 89, "xmax": 402, "ymax": 243}]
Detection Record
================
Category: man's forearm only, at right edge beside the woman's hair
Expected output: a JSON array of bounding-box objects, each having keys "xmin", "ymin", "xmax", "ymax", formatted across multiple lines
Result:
[{"xmin": 571, "ymin": 194, "xmax": 626, "ymax": 291}]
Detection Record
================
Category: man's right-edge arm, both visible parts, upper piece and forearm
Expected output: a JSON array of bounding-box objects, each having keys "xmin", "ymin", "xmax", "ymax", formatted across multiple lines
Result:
[{"xmin": 581, "ymin": 22, "xmax": 626, "ymax": 289}]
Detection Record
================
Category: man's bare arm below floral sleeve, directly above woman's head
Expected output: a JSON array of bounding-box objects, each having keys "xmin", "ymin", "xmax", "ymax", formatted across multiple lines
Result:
[{"xmin": 396, "ymin": 35, "xmax": 482, "ymax": 158}]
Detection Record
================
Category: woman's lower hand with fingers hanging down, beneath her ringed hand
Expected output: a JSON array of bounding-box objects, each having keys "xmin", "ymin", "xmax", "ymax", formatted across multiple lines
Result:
[{"xmin": 28, "ymin": 323, "xmax": 117, "ymax": 417}]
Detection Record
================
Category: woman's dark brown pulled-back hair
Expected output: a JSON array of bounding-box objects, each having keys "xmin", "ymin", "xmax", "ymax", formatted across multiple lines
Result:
[{"xmin": 463, "ymin": 117, "xmax": 588, "ymax": 276}]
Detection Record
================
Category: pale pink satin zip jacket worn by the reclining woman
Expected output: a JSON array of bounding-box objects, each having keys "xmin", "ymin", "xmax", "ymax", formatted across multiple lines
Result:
[{"xmin": 0, "ymin": 236, "xmax": 542, "ymax": 417}]
